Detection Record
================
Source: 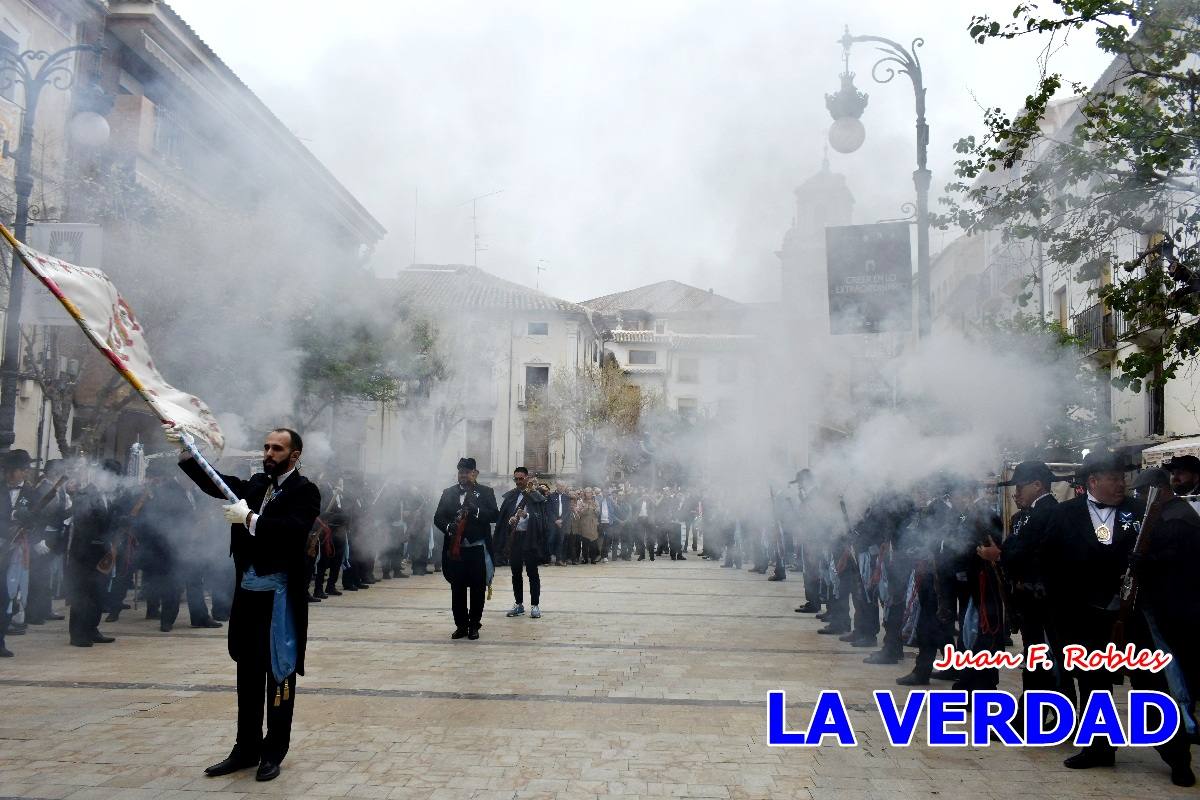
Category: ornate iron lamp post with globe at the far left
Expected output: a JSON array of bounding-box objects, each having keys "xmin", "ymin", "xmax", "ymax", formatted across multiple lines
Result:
[{"xmin": 0, "ymin": 44, "xmax": 107, "ymax": 450}]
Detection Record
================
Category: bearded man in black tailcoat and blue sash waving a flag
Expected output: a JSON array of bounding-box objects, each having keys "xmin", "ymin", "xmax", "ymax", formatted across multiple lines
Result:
[{"xmin": 167, "ymin": 428, "xmax": 320, "ymax": 781}]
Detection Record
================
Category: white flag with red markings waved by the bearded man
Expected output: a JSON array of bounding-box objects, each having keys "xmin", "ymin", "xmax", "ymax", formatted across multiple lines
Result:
[{"xmin": 0, "ymin": 225, "xmax": 224, "ymax": 459}]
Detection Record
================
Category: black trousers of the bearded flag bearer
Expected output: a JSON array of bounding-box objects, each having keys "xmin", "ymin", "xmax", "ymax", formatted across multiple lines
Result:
[{"xmin": 234, "ymin": 591, "xmax": 296, "ymax": 764}]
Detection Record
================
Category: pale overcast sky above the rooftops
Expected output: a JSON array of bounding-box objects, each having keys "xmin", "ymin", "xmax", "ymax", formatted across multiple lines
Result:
[{"xmin": 164, "ymin": 0, "xmax": 1105, "ymax": 300}]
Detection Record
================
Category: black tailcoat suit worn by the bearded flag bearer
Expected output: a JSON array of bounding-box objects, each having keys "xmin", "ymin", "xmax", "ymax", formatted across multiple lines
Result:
[{"xmin": 179, "ymin": 458, "xmax": 320, "ymax": 764}]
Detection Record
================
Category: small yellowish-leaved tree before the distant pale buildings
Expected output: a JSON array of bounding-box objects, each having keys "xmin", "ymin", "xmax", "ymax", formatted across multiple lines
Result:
[{"xmin": 529, "ymin": 354, "xmax": 659, "ymax": 479}]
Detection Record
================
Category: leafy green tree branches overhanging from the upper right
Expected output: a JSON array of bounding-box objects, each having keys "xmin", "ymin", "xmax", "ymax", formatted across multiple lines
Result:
[{"xmin": 943, "ymin": 0, "xmax": 1200, "ymax": 391}]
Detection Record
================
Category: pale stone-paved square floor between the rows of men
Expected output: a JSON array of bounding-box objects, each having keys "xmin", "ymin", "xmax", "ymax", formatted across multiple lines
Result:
[{"xmin": 0, "ymin": 558, "xmax": 1195, "ymax": 800}]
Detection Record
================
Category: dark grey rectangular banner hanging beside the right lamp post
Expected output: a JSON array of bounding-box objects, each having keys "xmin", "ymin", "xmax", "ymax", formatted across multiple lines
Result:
[{"xmin": 826, "ymin": 222, "xmax": 912, "ymax": 335}]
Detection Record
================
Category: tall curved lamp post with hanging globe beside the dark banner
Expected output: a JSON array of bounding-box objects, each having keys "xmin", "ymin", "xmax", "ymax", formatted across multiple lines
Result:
[{"xmin": 826, "ymin": 26, "xmax": 932, "ymax": 338}]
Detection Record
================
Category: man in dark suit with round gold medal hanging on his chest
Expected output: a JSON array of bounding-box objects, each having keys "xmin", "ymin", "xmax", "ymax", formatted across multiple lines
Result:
[{"xmin": 1043, "ymin": 451, "xmax": 1194, "ymax": 781}]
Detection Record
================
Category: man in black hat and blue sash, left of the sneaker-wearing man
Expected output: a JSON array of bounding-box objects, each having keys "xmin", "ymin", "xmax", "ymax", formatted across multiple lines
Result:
[{"xmin": 433, "ymin": 458, "xmax": 500, "ymax": 639}]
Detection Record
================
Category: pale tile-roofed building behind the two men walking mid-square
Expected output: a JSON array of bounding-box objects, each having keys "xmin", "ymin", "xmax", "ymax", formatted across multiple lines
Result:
[{"xmin": 364, "ymin": 265, "xmax": 600, "ymax": 476}]
